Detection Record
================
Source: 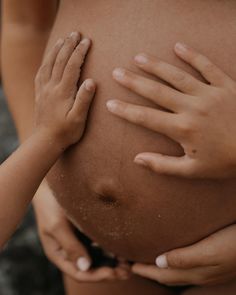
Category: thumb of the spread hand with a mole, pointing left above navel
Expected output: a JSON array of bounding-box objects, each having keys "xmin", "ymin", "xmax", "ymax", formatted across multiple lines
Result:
[{"xmin": 134, "ymin": 153, "xmax": 195, "ymax": 178}]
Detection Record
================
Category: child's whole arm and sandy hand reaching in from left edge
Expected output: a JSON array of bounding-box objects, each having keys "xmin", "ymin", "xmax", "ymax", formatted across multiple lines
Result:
[{"xmin": 0, "ymin": 33, "xmax": 95, "ymax": 247}]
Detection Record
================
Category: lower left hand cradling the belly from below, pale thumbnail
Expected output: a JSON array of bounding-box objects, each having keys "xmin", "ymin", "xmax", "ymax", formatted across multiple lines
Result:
[{"xmin": 34, "ymin": 181, "xmax": 128, "ymax": 282}]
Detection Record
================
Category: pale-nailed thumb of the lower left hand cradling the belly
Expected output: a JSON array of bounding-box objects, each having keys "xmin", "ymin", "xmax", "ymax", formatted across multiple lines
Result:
[{"xmin": 56, "ymin": 220, "xmax": 92, "ymax": 271}]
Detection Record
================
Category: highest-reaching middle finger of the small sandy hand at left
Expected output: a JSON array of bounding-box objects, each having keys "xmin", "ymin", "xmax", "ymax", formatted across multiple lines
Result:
[{"xmin": 52, "ymin": 32, "xmax": 80, "ymax": 82}]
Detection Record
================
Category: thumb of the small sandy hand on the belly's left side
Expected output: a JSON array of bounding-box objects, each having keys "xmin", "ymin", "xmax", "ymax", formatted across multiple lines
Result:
[{"xmin": 69, "ymin": 79, "xmax": 96, "ymax": 122}]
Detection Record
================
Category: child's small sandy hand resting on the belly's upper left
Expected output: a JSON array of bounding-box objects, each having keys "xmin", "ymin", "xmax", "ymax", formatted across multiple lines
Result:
[{"xmin": 35, "ymin": 32, "xmax": 95, "ymax": 149}]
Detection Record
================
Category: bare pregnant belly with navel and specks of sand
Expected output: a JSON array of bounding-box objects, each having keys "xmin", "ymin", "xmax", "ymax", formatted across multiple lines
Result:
[{"xmin": 48, "ymin": 0, "xmax": 236, "ymax": 262}]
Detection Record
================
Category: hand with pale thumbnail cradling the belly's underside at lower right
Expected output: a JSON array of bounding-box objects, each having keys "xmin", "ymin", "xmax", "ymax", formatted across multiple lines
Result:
[{"xmin": 132, "ymin": 225, "xmax": 236, "ymax": 285}]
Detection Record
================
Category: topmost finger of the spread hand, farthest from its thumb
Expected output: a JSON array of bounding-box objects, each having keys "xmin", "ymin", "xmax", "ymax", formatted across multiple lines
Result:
[{"xmin": 175, "ymin": 43, "xmax": 230, "ymax": 86}]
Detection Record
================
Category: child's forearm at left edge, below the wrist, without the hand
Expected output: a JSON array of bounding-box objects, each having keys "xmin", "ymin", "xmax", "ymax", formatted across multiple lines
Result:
[{"xmin": 0, "ymin": 132, "xmax": 62, "ymax": 248}]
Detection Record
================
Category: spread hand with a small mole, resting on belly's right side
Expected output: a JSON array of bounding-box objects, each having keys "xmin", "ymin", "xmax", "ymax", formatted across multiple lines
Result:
[{"xmin": 108, "ymin": 43, "xmax": 236, "ymax": 178}]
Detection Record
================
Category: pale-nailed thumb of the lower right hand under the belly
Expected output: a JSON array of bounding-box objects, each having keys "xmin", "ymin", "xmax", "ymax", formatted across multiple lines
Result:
[{"xmin": 156, "ymin": 243, "xmax": 213, "ymax": 269}]
